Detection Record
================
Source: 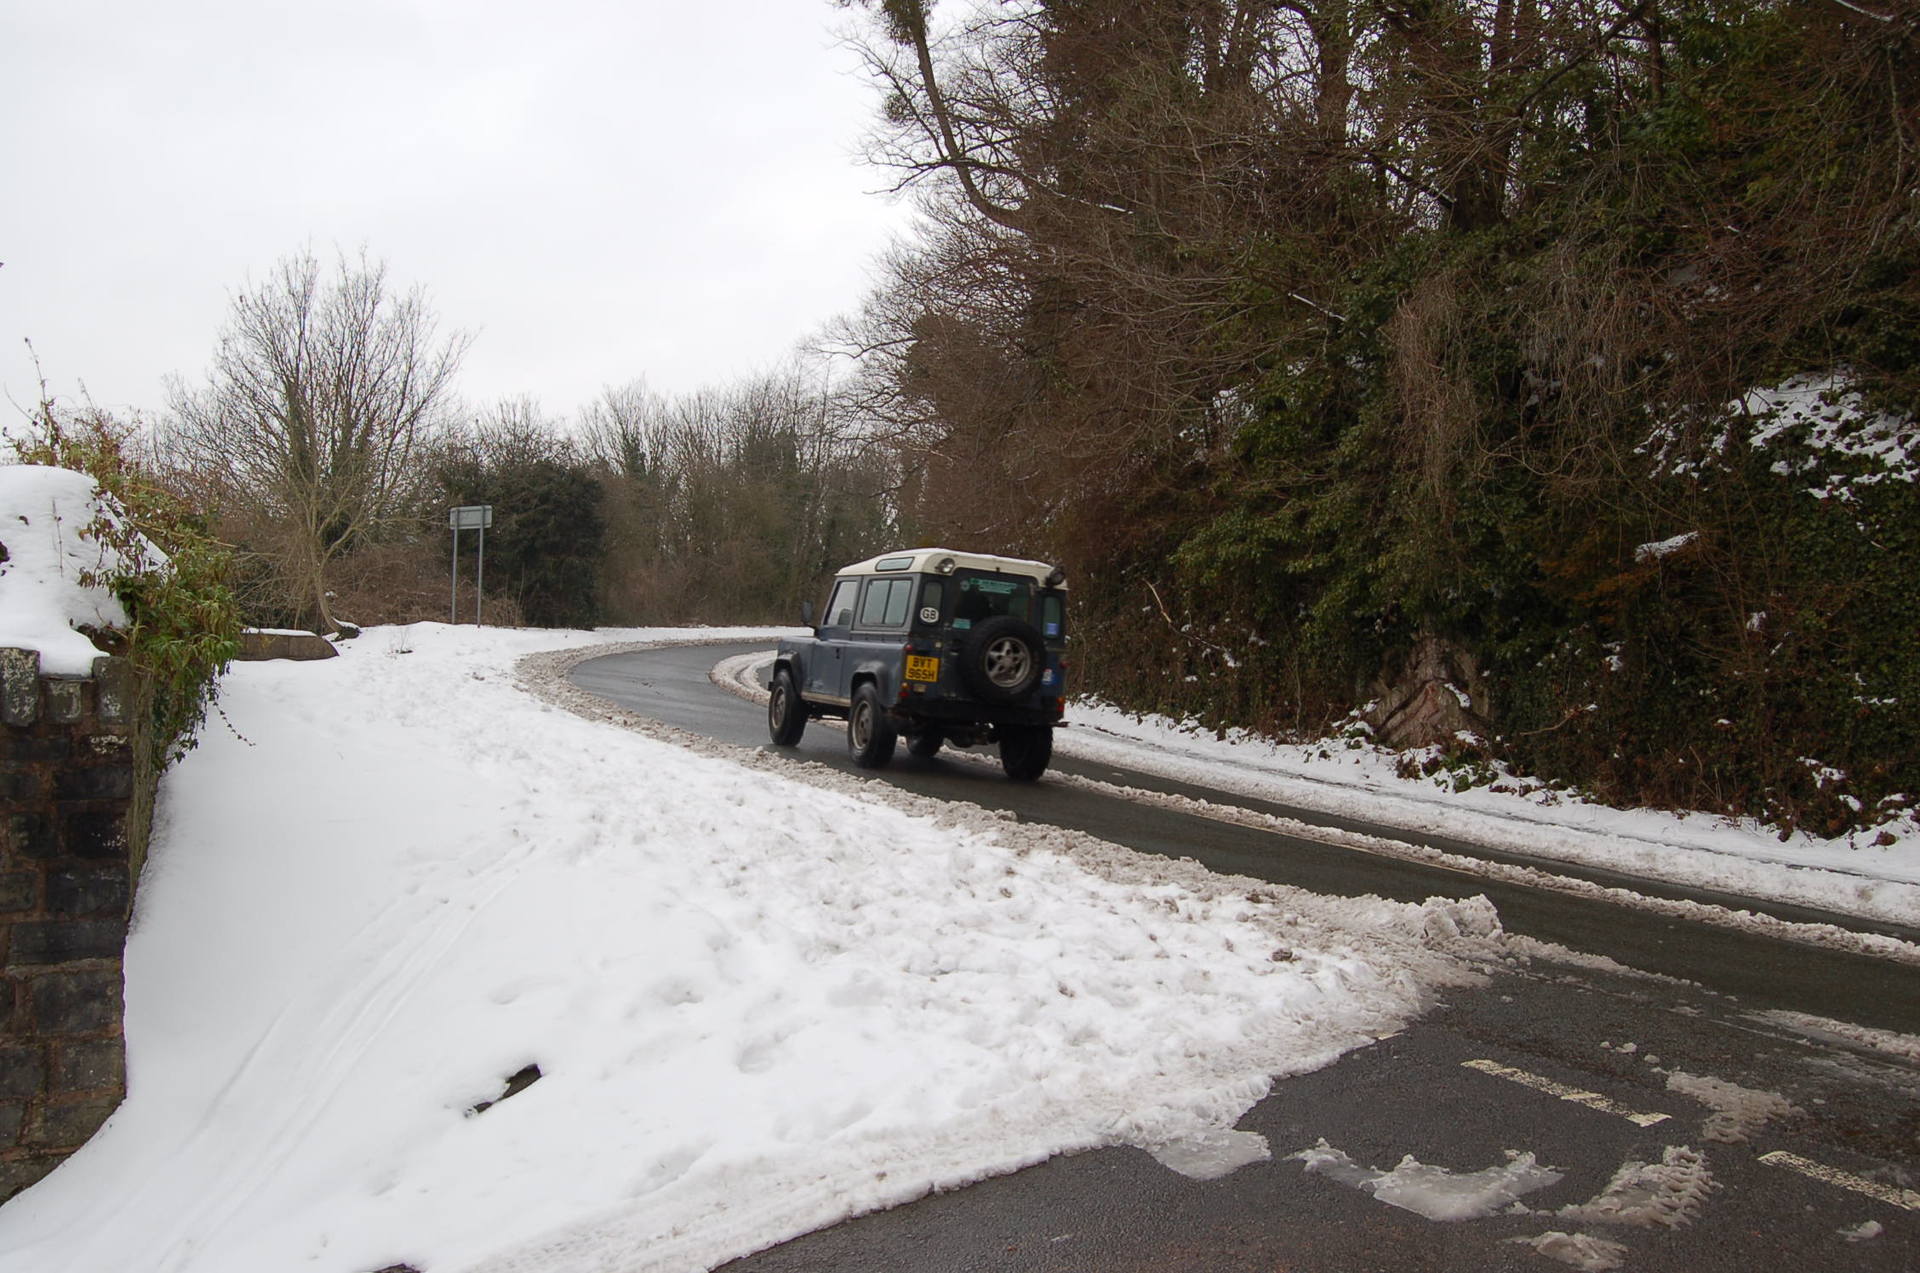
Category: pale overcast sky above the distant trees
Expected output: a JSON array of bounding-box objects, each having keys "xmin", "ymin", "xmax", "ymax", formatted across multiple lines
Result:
[{"xmin": 0, "ymin": 0, "xmax": 908, "ymax": 428}]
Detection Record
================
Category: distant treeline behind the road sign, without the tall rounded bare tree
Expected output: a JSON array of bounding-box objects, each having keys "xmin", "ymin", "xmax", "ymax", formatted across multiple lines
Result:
[{"xmin": 157, "ymin": 355, "xmax": 895, "ymax": 630}]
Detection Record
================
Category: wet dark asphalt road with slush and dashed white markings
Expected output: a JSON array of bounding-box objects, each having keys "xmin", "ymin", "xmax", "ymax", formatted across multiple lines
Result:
[{"xmin": 574, "ymin": 647, "xmax": 1920, "ymax": 1273}]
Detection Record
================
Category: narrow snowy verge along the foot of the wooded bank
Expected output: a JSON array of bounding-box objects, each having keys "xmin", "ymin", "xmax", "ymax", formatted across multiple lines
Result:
[{"xmin": 712, "ymin": 655, "xmax": 1920, "ymax": 936}]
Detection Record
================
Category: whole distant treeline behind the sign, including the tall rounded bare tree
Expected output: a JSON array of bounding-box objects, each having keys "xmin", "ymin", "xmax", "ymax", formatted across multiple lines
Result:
[{"xmin": 33, "ymin": 252, "xmax": 899, "ymax": 632}]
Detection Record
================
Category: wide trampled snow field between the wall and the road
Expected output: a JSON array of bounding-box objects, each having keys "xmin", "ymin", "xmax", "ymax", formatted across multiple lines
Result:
[{"xmin": 0, "ymin": 624, "xmax": 1509, "ymax": 1273}]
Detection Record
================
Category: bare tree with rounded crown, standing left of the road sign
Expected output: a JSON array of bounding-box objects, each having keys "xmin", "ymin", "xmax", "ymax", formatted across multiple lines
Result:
[{"xmin": 165, "ymin": 252, "xmax": 470, "ymax": 630}]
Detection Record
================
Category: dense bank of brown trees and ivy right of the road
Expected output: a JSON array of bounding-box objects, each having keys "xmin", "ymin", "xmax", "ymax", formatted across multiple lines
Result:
[{"xmin": 870, "ymin": 0, "xmax": 1920, "ymax": 833}]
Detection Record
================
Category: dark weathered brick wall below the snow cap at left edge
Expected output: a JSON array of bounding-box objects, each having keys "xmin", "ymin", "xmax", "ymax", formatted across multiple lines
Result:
[{"xmin": 0, "ymin": 649, "xmax": 136, "ymax": 1202}]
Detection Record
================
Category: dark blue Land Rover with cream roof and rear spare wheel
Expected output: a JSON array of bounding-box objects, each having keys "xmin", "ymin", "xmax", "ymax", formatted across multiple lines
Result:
[{"xmin": 766, "ymin": 547, "xmax": 1068, "ymax": 781}]
